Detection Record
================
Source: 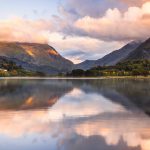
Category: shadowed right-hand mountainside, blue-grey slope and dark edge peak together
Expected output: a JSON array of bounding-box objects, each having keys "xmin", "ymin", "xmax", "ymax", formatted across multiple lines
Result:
[{"xmin": 75, "ymin": 39, "xmax": 150, "ymax": 70}]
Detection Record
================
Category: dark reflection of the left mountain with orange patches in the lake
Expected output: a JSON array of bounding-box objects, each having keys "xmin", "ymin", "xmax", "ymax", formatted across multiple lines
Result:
[{"xmin": 0, "ymin": 80, "xmax": 72, "ymax": 110}]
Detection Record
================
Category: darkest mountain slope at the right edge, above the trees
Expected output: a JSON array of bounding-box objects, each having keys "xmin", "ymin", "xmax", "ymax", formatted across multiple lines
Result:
[{"xmin": 125, "ymin": 38, "xmax": 150, "ymax": 60}]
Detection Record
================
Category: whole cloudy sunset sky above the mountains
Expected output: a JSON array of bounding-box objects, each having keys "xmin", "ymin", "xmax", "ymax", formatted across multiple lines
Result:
[{"xmin": 0, "ymin": 0, "xmax": 150, "ymax": 63}]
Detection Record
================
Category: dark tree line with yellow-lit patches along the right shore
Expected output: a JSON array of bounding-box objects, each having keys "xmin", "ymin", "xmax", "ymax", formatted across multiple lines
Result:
[{"xmin": 66, "ymin": 60, "xmax": 150, "ymax": 77}]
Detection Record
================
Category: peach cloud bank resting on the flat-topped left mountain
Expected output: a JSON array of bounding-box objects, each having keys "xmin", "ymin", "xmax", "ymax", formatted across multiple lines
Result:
[{"xmin": 0, "ymin": 17, "xmax": 53, "ymax": 43}]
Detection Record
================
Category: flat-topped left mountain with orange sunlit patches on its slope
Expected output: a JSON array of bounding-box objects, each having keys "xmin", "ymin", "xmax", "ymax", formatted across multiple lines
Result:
[{"xmin": 0, "ymin": 42, "xmax": 73, "ymax": 75}]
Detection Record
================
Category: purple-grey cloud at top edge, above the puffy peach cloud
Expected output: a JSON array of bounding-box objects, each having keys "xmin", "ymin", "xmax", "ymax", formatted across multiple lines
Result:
[{"xmin": 60, "ymin": 0, "xmax": 119, "ymax": 17}]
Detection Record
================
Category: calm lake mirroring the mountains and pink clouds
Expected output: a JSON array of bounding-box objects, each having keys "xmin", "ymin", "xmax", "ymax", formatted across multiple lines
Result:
[{"xmin": 0, "ymin": 79, "xmax": 150, "ymax": 150}]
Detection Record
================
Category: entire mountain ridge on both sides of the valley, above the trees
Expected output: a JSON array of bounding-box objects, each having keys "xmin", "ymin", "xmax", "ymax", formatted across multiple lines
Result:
[{"xmin": 0, "ymin": 38, "xmax": 150, "ymax": 75}]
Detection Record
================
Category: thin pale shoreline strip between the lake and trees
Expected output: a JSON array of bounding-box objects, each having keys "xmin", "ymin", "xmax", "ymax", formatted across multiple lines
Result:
[{"xmin": 0, "ymin": 76, "xmax": 150, "ymax": 80}]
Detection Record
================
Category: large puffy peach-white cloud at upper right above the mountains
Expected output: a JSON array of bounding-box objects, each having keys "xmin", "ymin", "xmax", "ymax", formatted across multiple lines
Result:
[{"xmin": 75, "ymin": 2, "xmax": 150, "ymax": 41}]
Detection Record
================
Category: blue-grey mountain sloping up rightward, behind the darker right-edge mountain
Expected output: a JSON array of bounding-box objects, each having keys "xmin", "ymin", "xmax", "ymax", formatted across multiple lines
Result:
[{"xmin": 75, "ymin": 41, "xmax": 141, "ymax": 70}]
